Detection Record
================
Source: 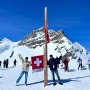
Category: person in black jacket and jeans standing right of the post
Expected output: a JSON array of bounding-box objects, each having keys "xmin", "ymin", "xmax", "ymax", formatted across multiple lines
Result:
[{"xmin": 47, "ymin": 55, "xmax": 63, "ymax": 85}]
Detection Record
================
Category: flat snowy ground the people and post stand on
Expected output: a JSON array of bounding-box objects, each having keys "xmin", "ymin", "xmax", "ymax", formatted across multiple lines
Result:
[{"xmin": 0, "ymin": 60, "xmax": 90, "ymax": 90}]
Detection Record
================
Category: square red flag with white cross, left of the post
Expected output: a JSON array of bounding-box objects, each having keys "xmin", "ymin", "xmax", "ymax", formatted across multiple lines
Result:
[{"xmin": 31, "ymin": 55, "xmax": 44, "ymax": 71}]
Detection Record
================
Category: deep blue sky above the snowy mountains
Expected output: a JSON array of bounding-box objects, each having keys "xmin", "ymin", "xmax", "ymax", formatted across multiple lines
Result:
[{"xmin": 0, "ymin": 0, "xmax": 90, "ymax": 51}]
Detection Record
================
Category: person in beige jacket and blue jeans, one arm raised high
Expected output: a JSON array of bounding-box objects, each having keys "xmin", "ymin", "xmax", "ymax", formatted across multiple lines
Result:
[{"xmin": 16, "ymin": 54, "xmax": 31, "ymax": 86}]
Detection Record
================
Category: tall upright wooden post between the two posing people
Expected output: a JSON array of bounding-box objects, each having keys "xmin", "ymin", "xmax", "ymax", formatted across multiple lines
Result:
[{"xmin": 44, "ymin": 7, "xmax": 48, "ymax": 87}]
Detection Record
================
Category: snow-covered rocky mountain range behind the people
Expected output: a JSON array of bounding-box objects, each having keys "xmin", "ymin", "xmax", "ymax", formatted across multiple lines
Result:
[{"xmin": 0, "ymin": 28, "xmax": 90, "ymax": 64}]
